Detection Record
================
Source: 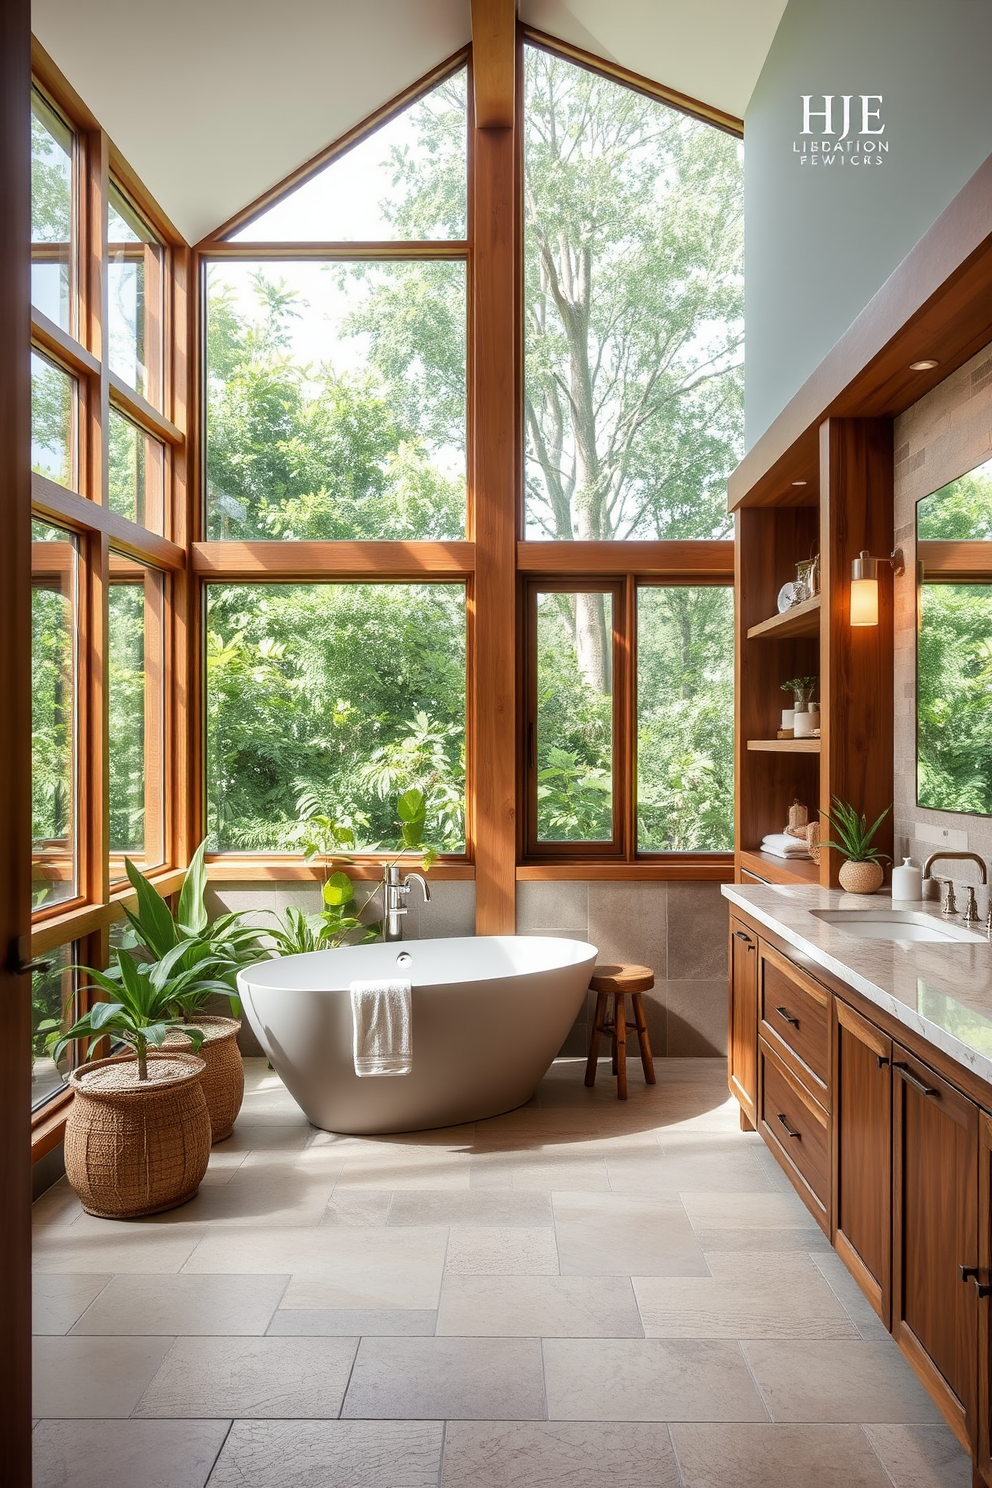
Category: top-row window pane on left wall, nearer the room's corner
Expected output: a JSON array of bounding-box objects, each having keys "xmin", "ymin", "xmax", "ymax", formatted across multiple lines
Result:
[{"xmin": 107, "ymin": 182, "xmax": 164, "ymax": 408}]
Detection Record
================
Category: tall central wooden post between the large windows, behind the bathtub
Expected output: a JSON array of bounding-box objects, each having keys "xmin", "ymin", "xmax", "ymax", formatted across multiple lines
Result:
[{"xmin": 470, "ymin": 0, "xmax": 521, "ymax": 934}]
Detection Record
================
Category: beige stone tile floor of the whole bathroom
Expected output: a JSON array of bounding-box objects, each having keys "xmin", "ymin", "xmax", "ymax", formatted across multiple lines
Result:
[{"xmin": 34, "ymin": 1059, "xmax": 971, "ymax": 1488}]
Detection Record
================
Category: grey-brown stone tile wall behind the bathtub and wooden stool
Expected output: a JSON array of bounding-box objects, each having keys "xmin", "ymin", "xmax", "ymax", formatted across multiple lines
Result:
[{"xmin": 211, "ymin": 881, "xmax": 727, "ymax": 1056}]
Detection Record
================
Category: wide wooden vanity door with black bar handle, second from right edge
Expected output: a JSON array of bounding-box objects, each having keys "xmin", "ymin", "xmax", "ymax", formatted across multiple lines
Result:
[{"xmin": 892, "ymin": 1043, "xmax": 979, "ymax": 1449}]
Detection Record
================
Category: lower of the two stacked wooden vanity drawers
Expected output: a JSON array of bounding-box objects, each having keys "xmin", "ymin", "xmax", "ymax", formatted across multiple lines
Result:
[{"xmin": 759, "ymin": 1039, "xmax": 830, "ymax": 1231}]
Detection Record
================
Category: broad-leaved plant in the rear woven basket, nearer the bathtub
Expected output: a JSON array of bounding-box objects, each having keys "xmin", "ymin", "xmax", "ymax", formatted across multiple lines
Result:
[{"xmin": 112, "ymin": 842, "xmax": 266, "ymax": 1141}]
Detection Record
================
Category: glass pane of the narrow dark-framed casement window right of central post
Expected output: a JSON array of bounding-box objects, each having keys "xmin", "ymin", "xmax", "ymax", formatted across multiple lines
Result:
[{"xmin": 537, "ymin": 594, "xmax": 613, "ymax": 842}]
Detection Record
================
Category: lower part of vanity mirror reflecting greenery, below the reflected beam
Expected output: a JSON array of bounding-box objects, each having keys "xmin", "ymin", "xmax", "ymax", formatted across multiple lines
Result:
[{"xmin": 916, "ymin": 580, "xmax": 992, "ymax": 815}]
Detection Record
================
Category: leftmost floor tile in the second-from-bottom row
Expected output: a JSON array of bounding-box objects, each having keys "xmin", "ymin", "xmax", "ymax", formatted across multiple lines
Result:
[{"xmin": 31, "ymin": 1338, "xmax": 176, "ymax": 1421}]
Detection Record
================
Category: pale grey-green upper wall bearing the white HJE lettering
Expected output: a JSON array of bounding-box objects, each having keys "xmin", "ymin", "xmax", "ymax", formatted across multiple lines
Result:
[{"xmin": 745, "ymin": 0, "xmax": 992, "ymax": 448}]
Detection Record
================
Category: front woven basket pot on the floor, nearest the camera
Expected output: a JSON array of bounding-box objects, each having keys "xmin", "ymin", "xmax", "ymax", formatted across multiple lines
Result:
[{"xmin": 65, "ymin": 1052, "xmax": 210, "ymax": 1219}]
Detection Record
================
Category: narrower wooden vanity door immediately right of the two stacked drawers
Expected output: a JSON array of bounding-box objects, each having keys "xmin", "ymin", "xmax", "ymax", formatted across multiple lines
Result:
[{"xmin": 833, "ymin": 1000, "xmax": 892, "ymax": 1327}]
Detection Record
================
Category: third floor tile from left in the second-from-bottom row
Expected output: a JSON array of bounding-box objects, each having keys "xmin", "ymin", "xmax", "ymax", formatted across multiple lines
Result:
[{"xmin": 341, "ymin": 1338, "xmax": 547, "ymax": 1421}]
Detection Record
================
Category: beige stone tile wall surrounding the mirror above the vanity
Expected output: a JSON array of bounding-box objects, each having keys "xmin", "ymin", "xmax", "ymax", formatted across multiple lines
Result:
[{"xmin": 894, "ymin": 337, "xmax": 992, "ymax": 912}]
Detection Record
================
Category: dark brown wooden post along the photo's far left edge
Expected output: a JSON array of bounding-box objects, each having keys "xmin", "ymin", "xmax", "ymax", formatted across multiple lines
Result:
[{"xmin": 0, "ymin": 0, "xmax": 31, "ymax": 1484}]
